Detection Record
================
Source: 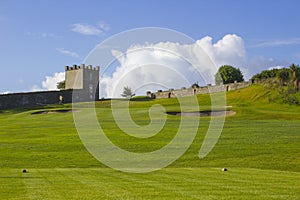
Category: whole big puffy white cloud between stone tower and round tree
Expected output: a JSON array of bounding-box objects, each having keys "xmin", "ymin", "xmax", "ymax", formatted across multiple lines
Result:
[{"xmin": 100, "ymin": 35, "xmax": 248, "ymax": 97}]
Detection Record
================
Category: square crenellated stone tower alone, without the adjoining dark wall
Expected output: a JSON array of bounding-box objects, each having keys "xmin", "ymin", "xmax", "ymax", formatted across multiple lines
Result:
[{"xmin": 65, "ymin": 64, "xmax": 100, "ymax": 100}]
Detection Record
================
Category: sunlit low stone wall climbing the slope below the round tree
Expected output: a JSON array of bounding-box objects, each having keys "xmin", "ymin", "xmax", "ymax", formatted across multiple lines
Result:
[{"xmin": 147, "ymin": 80, "xmax": 253, "ymax": 99}]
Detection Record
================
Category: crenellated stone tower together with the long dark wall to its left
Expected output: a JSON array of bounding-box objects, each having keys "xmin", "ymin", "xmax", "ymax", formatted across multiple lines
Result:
[{"xmin": 0, "ymin": 64, "xmax": 100, "ymax": 110}]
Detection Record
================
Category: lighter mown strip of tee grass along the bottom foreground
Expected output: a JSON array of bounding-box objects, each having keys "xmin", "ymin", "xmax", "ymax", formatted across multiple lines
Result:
[{"xmin": 0, "ymin": 168, "xmax": 300, "ymax": 199}]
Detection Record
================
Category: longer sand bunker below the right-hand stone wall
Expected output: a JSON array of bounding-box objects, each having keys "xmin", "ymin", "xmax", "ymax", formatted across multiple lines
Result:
[{"xmin": 166, "ymin": 110, "xmax": 236, "ymax": 117}]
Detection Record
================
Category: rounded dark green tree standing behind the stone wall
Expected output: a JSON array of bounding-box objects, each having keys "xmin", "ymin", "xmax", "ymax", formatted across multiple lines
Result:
[{"xmin": 215, "ymin": 65, "xmax": 244, "ymax": 85}]
